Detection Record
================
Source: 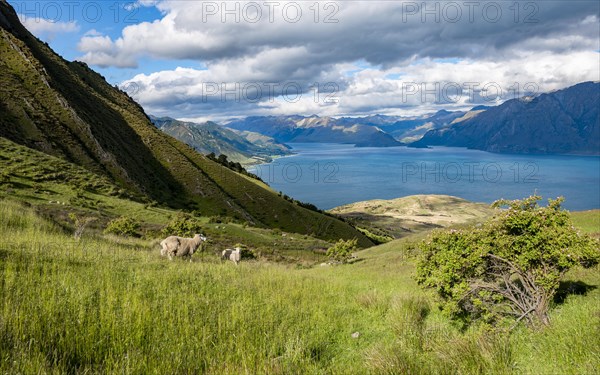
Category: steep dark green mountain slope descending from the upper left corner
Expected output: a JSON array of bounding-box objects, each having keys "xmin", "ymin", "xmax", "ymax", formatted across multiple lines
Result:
[{"xmin": 0, "ymin": 0, "xmax": 370, "ymax": 246}]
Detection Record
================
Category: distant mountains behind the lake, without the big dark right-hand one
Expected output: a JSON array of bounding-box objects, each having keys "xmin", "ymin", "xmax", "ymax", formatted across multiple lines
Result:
[{"xmin": 150, "ymin": 110, "xmax": 466, "ymax": 159}]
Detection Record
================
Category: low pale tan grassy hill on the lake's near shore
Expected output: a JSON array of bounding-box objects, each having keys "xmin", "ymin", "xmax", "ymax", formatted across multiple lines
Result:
[{"xmin": 329, "ymin": 195, "xmax": 493, "ymax": 242}]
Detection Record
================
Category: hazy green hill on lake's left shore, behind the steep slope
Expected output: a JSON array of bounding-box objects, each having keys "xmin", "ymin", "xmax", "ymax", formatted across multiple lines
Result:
[{"xmin": 150, "ymin": 116, "xmax": 291, "ymax": 164}]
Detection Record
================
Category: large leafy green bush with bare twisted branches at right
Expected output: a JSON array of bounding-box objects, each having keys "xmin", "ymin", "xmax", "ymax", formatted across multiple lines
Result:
[{"xmin": 417, "ymin": 196, "xmax": 600, "ymax": 326}]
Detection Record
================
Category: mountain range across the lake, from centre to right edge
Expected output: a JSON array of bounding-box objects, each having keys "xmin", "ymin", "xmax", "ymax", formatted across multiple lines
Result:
[{"xmin": 219, "ymin": 82, "xmax": 600, "ymax": 155}]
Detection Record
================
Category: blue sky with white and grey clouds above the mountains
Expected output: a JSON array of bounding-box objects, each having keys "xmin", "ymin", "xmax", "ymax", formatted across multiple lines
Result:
[{"xmin": 9, "ymin": 0, "xmax": 600, "ymax": 121}]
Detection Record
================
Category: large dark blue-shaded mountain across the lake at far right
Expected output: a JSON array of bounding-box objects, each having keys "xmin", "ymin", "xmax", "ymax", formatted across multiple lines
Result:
[{"xmin": 411, "ymin": 82, "xmax": 600, "ymax": 155}]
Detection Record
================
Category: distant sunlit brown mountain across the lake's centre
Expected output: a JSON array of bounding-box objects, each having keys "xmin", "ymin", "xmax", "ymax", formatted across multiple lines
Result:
[{"xmin": 225, "ymin": 116, "xmax": 402, "ymax": 147}]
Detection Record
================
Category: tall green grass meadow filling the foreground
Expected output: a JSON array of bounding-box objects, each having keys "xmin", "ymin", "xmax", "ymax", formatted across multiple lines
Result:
[{"xmin": 0, "ymin": 200, "xmax": 600, "ymax": 374}]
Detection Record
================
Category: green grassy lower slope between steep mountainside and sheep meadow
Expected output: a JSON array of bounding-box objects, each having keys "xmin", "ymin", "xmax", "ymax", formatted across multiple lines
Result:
[{"xmin": 0, "ymin": 138, "xmax": 342, "ymax": 265}]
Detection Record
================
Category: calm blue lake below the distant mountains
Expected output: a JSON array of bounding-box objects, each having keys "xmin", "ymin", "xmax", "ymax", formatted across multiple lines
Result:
[{"xmin": 249, "ymin": 143, "xmax": 600, "ymax": 210}]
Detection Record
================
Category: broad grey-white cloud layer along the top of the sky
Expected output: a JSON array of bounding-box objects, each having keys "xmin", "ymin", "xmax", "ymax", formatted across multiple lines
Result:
[{"xmin": 79, "ymin": 0, "xmax": 598, "ymax": 65}]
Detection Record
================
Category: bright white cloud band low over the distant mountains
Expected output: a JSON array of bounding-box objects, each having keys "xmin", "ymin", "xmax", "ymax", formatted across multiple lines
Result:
[{"xmin": 123, "ymin": 48, "xmax": 600, "ymax": 118}]
